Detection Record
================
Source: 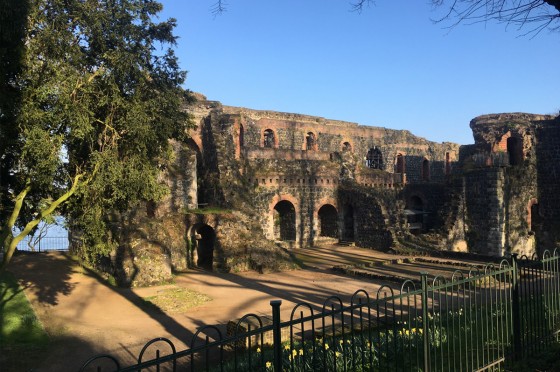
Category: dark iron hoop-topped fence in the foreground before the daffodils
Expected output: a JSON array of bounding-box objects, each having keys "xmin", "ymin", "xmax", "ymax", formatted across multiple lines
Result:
[{"xmin": 82, "ymin": 251, "xmax": 560, "ymax": 371}]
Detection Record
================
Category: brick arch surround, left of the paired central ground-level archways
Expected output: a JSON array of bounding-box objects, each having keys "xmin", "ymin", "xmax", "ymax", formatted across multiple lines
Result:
[{"xmin": 267, "ymin": 194, "xmax": 300, "ymax": 242}]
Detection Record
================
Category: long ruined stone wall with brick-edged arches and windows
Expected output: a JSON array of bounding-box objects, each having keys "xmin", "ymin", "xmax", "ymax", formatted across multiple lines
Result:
[{"xmin": 101, "ymin": 95, "xmax": 560, "ymax": 285}]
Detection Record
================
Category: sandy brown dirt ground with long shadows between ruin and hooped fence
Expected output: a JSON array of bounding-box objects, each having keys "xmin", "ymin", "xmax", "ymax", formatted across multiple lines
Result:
[{"xmin": 3, "ymin": 246, "xmax": 486, "ymax": 371}]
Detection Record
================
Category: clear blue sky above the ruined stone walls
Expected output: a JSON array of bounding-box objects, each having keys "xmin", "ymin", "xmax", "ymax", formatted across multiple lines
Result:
[{"xmin": 156, "ymin": 0, "xmax": 560, "ymax": 144}]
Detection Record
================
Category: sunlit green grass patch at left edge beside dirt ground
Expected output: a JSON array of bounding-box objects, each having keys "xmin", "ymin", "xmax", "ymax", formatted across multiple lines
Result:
[{"xmin": 0, "ymin": 272, "xmax": 48, "ymax": 346}]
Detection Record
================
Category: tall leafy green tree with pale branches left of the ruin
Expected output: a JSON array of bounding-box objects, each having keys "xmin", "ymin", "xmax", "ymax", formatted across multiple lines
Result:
[{"xmin": 0, "ymin": 0, "xmax": 191, "ymax": 269}]
